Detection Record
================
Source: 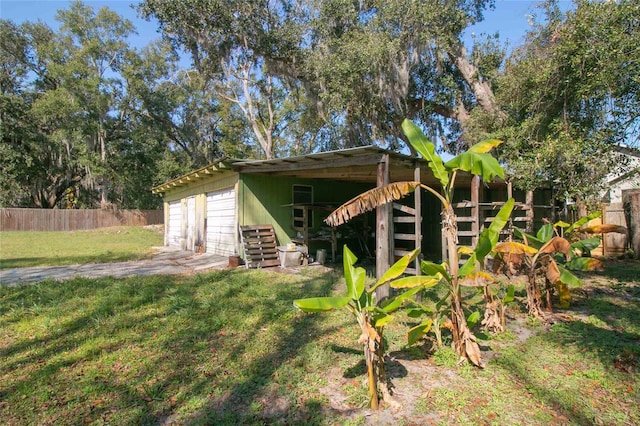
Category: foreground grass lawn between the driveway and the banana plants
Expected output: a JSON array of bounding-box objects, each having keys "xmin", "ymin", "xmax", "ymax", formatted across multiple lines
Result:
[{"xmin": 0, "ymin": 262, "xmax": 640, "ymax": 425}]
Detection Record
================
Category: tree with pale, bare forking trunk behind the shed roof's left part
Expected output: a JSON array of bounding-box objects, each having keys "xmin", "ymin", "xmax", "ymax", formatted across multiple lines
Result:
[{"xmin": 140, "ymin": 0, "xmax": 302, "ymax": 159}]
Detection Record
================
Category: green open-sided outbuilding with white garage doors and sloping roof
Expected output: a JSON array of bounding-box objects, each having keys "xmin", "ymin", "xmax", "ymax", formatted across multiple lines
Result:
[{"xmin": 153, "ymin": 146, "xmax": 551, "ymax": 270}]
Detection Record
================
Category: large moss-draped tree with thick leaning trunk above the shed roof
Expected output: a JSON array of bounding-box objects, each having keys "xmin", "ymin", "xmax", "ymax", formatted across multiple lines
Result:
[{"xmin": 296, "ymin": 0, "xmax": 501, "ymax": 151}]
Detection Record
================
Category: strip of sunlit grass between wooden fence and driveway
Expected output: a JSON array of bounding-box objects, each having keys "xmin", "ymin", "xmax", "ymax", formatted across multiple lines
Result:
[{"xmin": 0, "ymin": 226, "xmax": 163, "ymax": 268}]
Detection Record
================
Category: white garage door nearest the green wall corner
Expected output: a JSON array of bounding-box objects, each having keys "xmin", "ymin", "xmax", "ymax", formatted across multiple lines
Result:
[{"xmin": 207, "ymin": 188, "xmax": 237, "ymax": 256}]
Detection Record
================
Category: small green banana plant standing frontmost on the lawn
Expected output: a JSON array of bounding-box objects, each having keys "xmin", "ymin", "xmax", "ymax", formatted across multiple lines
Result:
[{"xmin": 293, "ymin": 245, "xmax": 437, "ymax": 410}]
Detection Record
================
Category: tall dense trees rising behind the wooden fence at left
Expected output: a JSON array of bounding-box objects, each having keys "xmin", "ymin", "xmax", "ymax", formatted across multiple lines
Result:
[{"xmin": 0, "ymin": 2, "xmax": 182, "ymax": 208}]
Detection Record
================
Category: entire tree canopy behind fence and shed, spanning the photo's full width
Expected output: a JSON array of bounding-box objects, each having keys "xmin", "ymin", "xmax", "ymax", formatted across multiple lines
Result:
[{"xmin": 0, "ymin": 0, "xmax": 640, "ymax": 211}]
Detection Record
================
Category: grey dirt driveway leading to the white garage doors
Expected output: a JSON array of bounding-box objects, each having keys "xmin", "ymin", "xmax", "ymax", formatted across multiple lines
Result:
[{"xmin": 0, "ymin": 247, "xmax": 228, "ymax": 287}]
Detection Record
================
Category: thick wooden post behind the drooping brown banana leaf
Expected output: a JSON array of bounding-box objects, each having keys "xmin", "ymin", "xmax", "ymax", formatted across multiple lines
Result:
[{"xmin": 376, "ymin": 154, "xmax": 393, "ymax": 301}]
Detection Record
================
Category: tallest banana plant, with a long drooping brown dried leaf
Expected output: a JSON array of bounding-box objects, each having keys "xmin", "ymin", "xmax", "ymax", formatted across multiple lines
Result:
[{"xmin": 325, "ymin": 120, "xmax": 513, "ymax": 366}]
